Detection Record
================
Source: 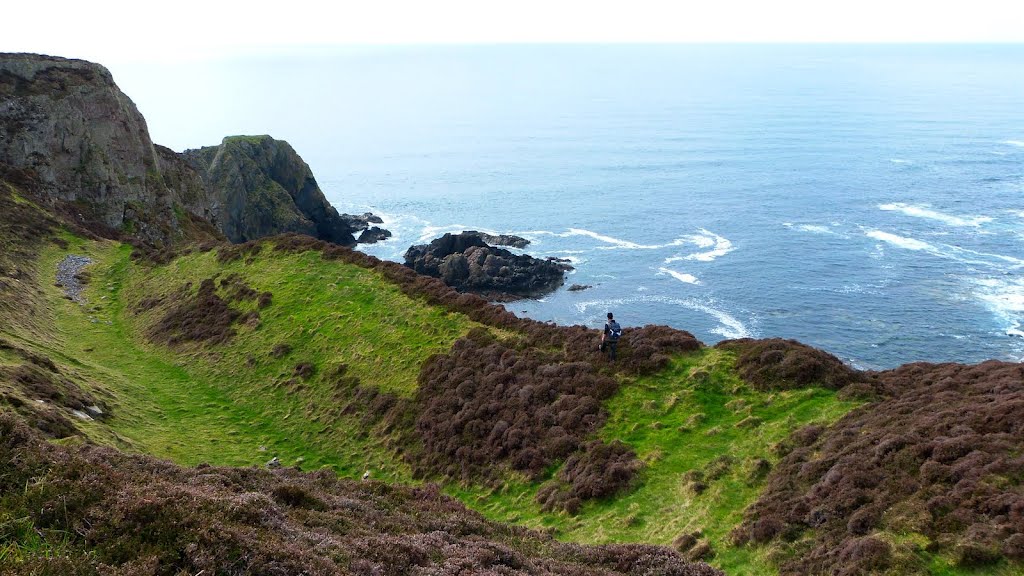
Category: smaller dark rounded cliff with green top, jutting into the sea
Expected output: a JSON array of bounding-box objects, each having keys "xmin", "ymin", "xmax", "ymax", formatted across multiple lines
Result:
[{"xmin": 182, "ymin": 136, "xmax": 367, "ymax": 245}]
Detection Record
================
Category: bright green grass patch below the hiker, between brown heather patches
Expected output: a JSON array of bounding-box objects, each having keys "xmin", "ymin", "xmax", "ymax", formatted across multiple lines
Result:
[{"xmin": 459, "ymin": 348, "xmax": 855, "ymax": 574}]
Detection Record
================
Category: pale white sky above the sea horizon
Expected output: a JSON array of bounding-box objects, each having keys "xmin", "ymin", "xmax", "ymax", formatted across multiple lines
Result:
[{"xmin": 8, "ymin": 0, "xmax": 1024, "ymax": 65}]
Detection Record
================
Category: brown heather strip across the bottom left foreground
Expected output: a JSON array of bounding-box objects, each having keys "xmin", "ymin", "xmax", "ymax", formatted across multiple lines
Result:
[{"xmin": 0, "ymin": 415, "xmax": 721, "ymax": 576}]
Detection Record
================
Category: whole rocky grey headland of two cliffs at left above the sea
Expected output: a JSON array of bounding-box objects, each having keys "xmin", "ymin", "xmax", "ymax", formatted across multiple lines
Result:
[{"xmin": 0, "ymin": 53, "xmax": 376, "ymax": 245}]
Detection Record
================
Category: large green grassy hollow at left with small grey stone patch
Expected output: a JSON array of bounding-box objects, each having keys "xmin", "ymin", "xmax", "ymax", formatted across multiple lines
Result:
[{"xmin": 0, "ymin": 236, "xmax": 473, "ymax": 482}]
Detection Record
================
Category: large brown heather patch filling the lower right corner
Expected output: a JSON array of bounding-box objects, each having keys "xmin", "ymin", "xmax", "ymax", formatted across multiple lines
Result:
[{"xmin": 734, "ymin": 361, "xmax": 1024, "ymax": 574}]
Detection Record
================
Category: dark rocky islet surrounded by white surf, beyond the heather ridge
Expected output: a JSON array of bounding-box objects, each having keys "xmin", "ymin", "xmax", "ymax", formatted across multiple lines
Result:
[{"xmin": 406, "ymin": 232, "xmax": 572, "ymax": 300}]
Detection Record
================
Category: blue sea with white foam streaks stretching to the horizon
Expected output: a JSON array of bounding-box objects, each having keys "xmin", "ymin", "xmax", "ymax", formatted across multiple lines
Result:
[{"xmin": 116, "ymin": 45, "xmax": 1024, "ymax": 369}]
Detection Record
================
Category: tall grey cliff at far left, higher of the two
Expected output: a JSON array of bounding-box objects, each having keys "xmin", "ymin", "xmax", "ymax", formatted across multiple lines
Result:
[{"xmin": 0, "ymin": 54, "xmax": 190, "ymax": 242}]
